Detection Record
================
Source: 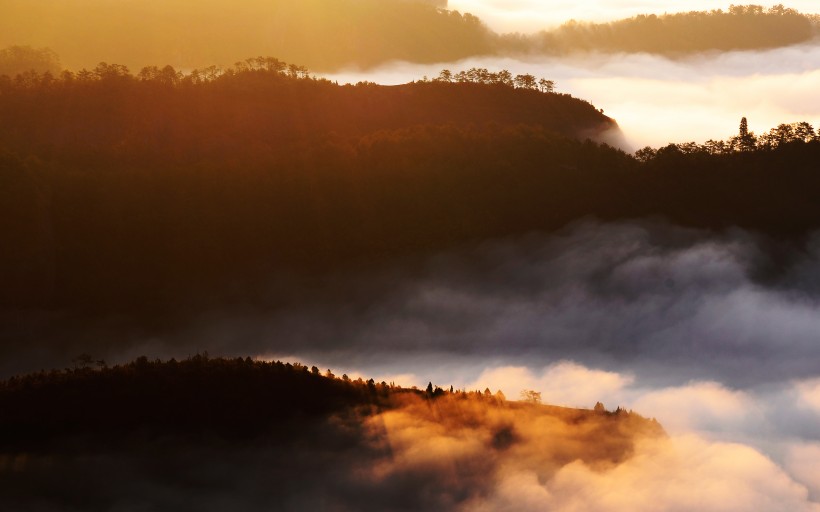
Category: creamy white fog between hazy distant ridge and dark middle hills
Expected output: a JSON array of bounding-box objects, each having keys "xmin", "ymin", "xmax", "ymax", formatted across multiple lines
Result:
[{"xmin": 327, "ymin": 45, "xmax": 820, "ymax": 151}]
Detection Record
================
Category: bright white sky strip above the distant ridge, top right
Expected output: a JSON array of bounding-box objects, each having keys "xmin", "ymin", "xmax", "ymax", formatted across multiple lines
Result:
[{"xmin": 448, "ymin": 0, "xmax": 818, "ymax": 33}]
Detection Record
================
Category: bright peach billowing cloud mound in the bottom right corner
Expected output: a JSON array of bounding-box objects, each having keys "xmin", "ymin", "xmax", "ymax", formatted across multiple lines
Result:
[{"xmin": 464, "ymin": 436, "xmax": 820, "ymax": 512}]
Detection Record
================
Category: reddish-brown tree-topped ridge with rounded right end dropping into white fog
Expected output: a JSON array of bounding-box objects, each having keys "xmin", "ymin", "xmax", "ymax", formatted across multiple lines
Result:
[{"xmin": 0, "ymin": 61, "xmax": 617, "ymax": 160}]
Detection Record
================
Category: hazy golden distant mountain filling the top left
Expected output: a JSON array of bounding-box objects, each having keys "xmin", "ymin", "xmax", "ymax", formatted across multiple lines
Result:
[{"xmin": 0, "ymin": 0, "xmax": 495, "ymax": 71}]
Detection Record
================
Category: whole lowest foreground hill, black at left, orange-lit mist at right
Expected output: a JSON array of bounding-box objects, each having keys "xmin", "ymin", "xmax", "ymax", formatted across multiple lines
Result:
[{"xmin": 0, "ymin": 355, "xmax": 664, "ymax": 511}]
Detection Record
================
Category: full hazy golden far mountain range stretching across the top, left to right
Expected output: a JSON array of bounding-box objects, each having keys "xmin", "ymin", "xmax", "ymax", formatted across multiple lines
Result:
[{"xmin": 0, "ymin": 0, "xmax": 818, "ymax": 71}]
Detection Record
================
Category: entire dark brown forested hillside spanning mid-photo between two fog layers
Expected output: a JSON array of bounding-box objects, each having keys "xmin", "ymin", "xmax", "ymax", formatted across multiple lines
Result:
[{"xmin": 0, "ymin": 59, "xmax": 820, "ymax": 312}]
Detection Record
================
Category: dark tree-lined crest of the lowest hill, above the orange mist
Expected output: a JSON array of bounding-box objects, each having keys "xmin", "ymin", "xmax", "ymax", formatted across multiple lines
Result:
[{"xmin": 0, "ymin": 352, "xmax": 662, "ymax": 452}]
